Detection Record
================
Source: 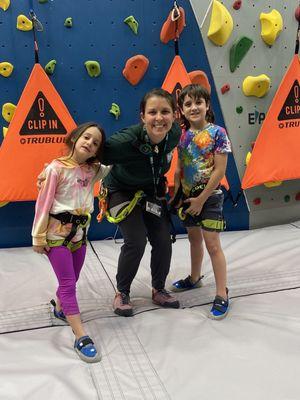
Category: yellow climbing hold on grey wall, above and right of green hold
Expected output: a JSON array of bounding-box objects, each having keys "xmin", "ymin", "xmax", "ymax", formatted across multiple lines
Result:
[{"xmin": 259, "ymin": 10, "xmax": 283, "ymax": 46}]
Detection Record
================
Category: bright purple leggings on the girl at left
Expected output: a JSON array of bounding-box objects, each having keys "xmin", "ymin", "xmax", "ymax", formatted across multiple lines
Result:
[{"xmin": 48, "ymin": 245, "xmax": 86, "ymax": 315}]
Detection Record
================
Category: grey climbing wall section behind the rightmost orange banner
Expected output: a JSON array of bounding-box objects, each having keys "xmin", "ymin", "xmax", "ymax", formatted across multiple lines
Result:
[{"xmin": 191, "ymin": 0, "xmax": 300, "ymax": 228}]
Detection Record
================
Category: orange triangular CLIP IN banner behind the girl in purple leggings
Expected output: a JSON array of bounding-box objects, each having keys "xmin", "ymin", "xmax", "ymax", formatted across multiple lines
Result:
[{"xmin": 0, "ymin": 64, "xmax": 76, "ymax": 201}]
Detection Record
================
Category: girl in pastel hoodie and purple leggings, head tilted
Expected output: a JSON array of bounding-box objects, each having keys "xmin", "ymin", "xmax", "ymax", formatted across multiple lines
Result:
[{"xmin": 32, "ymin": 122, "xmax": 110, "ymax": 362}]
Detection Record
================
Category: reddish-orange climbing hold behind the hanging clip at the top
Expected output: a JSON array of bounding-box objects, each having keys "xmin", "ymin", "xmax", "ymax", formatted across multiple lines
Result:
[{"xmin": 160, "ymin": 7, "xmax": 185, "ymax": 44}]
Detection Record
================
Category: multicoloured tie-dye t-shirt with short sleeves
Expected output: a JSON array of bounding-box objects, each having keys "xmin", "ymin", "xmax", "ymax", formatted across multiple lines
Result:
[{"xmin": 178, "ymin": 124, "xmax": 231, "ymax": 195}]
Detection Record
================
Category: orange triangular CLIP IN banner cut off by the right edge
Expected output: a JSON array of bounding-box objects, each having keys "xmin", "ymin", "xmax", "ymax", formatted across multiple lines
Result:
[{"xmin": 242, "ymin": 54, "xmax": 300, "ymax": 189}]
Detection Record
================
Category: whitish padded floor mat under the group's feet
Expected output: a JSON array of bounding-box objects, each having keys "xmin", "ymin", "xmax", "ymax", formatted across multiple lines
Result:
[{"xmin": 0, "ymin": 222, "xmax": 300, "ymax": 400}]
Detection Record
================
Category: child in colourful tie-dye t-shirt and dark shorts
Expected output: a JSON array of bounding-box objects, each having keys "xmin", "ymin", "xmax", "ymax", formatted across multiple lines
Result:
[{"xmin": 172, "ymin": 85, "xmax": 231, "ymax": 319}]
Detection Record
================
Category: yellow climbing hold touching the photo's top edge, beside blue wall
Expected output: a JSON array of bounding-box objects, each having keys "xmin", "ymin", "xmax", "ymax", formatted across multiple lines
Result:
[{"xmin": 207, "ymin": 0, "xmax": 233, "ymax": 46}]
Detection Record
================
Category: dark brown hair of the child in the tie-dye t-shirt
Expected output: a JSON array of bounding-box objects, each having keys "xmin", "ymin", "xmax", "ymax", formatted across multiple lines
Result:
[{"xmin": 178, "ymin": 84, "xmax": 215, "ymax": 129}]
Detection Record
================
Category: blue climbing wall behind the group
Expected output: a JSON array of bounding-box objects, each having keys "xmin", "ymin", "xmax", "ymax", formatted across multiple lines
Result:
[{"xmin": 0, "ymin": 0, "xmax": 248, "ymax": 247}]
